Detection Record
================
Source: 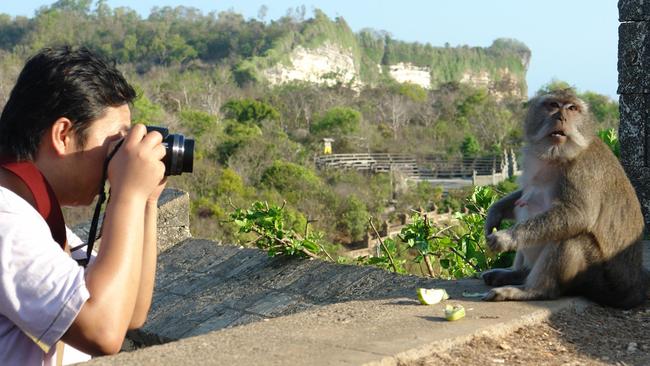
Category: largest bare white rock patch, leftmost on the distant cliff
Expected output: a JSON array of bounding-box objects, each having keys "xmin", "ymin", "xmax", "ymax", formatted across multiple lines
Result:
[{"xmin": 263, "ymin": 43, "xmax": 361, "ymax": 89}]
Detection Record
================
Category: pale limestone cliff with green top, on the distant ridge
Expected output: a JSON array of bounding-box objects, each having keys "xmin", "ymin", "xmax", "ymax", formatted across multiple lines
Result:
[{"xmin": 237, "ymin": 11, "xmax": 530, "ymax": 99}]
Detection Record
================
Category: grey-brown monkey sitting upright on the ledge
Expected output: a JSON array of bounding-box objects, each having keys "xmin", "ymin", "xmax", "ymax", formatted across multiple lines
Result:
[{"xmin": 481, "ymin": 89, "xmax": 648, "ymax": 309}]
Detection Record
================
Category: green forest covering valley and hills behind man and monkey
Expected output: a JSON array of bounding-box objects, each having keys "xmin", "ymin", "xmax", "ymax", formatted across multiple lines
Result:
[{"xmin": 0, "ymin": 0, "xmax": 618, "ymax": 252}]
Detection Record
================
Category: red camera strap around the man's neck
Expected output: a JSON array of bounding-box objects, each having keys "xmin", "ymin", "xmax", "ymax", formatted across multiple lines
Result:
[{"xmin": 0, "ymin": 156, "xmax": 66, "ymax": 248}]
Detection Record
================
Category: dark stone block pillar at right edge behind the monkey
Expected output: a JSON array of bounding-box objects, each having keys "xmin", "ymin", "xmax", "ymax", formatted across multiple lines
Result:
[{"xmin": 618, "ymin": 0, "xmax": 650, "ymax": 225}]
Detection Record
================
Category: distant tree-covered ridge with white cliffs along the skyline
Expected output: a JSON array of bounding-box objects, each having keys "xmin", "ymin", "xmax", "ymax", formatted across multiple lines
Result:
[{"xmin": 0, "ymin": 4, "xmax": 530, "ymax": 99}]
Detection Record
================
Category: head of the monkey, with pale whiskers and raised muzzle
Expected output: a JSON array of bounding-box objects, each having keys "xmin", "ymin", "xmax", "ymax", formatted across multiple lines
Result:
[{"xmin": 524, "ymin": 91, "xmax": 593, "ymax": 160}]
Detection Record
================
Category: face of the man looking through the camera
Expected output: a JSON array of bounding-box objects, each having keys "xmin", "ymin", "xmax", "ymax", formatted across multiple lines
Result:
[{"xmin": 62, "ymin": 104, "xmax": 131, "ymax": 206}]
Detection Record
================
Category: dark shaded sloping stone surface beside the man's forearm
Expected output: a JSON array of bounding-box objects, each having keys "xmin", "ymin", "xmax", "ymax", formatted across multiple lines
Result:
[{"xmin": 129, "ymin": 239, "xmax": 450, "ymax": 345}]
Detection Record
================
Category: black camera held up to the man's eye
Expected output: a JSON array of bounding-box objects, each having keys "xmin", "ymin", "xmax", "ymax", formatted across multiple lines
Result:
[{"xmin": 147, "ymin": 126, "xmax": 194, "ymax": 175}]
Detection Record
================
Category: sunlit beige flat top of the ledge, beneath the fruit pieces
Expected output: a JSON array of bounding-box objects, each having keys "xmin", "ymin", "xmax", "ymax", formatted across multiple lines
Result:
[{"xmin": 81, "ymin": 286, "xmax": 586, "ymax": 365}]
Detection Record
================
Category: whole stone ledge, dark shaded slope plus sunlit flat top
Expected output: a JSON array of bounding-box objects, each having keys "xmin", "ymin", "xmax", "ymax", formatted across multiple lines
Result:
[{"xmin": 78, "ymin": 239, "xmax": 620, "ymax": 365}]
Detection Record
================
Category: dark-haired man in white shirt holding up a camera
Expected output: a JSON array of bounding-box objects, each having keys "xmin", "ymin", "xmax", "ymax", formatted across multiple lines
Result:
[{"xmin": 0, "ymin": 47, "xmax": 165, "ymax": 365}]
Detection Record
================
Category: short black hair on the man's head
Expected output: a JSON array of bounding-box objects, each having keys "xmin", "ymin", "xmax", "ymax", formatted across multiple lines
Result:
[{"xmin": 0, "ymin": 46, "xmax": 136, "ymax": 160}]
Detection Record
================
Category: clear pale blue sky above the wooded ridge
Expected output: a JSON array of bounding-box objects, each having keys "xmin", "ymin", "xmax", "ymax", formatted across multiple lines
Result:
[{"xmin": 0, "ymin": 0, "xmax": 619, "ymax": 99}]
